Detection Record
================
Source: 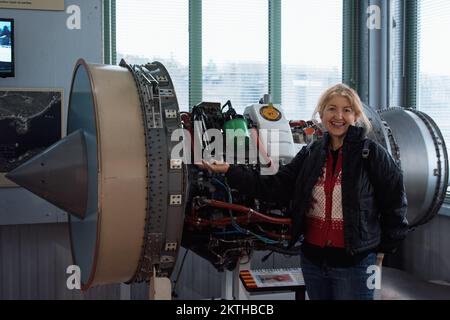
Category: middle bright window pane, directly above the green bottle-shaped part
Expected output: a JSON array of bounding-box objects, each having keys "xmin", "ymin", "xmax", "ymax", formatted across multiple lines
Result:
[{"xmin": 202, "ymin": 0, "xmax": 269, "ymax": 112}]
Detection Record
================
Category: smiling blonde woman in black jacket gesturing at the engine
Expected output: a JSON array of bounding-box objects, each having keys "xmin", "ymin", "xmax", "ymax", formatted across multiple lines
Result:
[{"xmin": 199, "ymin": 84, "xmax": 408, "ymax": 299}]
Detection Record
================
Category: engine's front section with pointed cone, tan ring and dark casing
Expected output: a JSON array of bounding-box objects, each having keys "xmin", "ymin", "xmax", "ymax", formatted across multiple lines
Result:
[{"xmin": 8, "ymin": 60, "xmax": 186, "ymax": 289}]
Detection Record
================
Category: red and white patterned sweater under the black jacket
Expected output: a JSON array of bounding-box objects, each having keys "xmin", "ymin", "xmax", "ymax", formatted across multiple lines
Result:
[{"xmin": 305, "ymin": 148, "xmax": 344, "ymax": 248}]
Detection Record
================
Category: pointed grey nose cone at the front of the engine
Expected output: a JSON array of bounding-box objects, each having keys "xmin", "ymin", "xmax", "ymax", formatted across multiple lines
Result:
[{"xmin": 6, "ymin": 130, "xmax": 88, "ymax": 219}]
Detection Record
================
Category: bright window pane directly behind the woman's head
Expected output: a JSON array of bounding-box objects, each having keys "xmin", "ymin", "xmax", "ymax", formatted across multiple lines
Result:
[{"xmin": 281, "ymin": 0, "xmax": 343, "ymax": 120}]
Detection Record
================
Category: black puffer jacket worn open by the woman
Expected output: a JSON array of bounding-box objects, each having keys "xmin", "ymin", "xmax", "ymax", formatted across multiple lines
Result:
[{"xmin": 227, "ymin": 126, "xmax": 408, "ymax": 255}]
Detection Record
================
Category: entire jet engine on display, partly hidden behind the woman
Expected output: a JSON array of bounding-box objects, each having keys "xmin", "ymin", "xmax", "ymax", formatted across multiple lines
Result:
[{"xmin": 7, "ymin": 60, "xmax": 448, "ymax": 289}]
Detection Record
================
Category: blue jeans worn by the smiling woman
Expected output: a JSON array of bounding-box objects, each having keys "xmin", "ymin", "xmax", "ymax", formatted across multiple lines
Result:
[{"xmin": 301, "ymin": 253, "xmax": 377, "ymax": 300}]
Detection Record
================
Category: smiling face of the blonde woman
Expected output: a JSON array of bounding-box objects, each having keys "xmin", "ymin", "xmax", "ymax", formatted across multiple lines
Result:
[{"xmin": 320, "ymin": 95, "xmax": 358, "ymax": 145}]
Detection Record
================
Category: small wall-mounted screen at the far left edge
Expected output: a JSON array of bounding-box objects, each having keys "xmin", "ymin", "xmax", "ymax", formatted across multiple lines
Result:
[{"xmin": 0, "ymin": 18, "xmax": 14, "ymax": 78}]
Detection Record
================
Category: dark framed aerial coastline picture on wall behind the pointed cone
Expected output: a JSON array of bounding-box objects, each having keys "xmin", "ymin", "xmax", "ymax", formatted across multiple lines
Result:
[{"xmin": 0, "ymin": 88, "xmax": 64, "ymax": 187}]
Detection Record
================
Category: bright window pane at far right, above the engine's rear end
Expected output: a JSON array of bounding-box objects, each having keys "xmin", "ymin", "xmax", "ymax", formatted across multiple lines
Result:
[{"xmin": 418, "ymin": 0, "xmax": 450, "ymax": 191}]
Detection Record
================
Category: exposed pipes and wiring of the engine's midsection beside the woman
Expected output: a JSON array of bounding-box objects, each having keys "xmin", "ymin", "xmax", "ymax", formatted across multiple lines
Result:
[{"xmin": 181, "ymin": 101, "xmax": 302, "ymax": 270}]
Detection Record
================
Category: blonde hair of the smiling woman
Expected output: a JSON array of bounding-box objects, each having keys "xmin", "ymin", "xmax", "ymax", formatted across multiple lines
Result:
[{"xmin": 313, "ymin": 83, "xmax": 372, "ymax": 134}]
